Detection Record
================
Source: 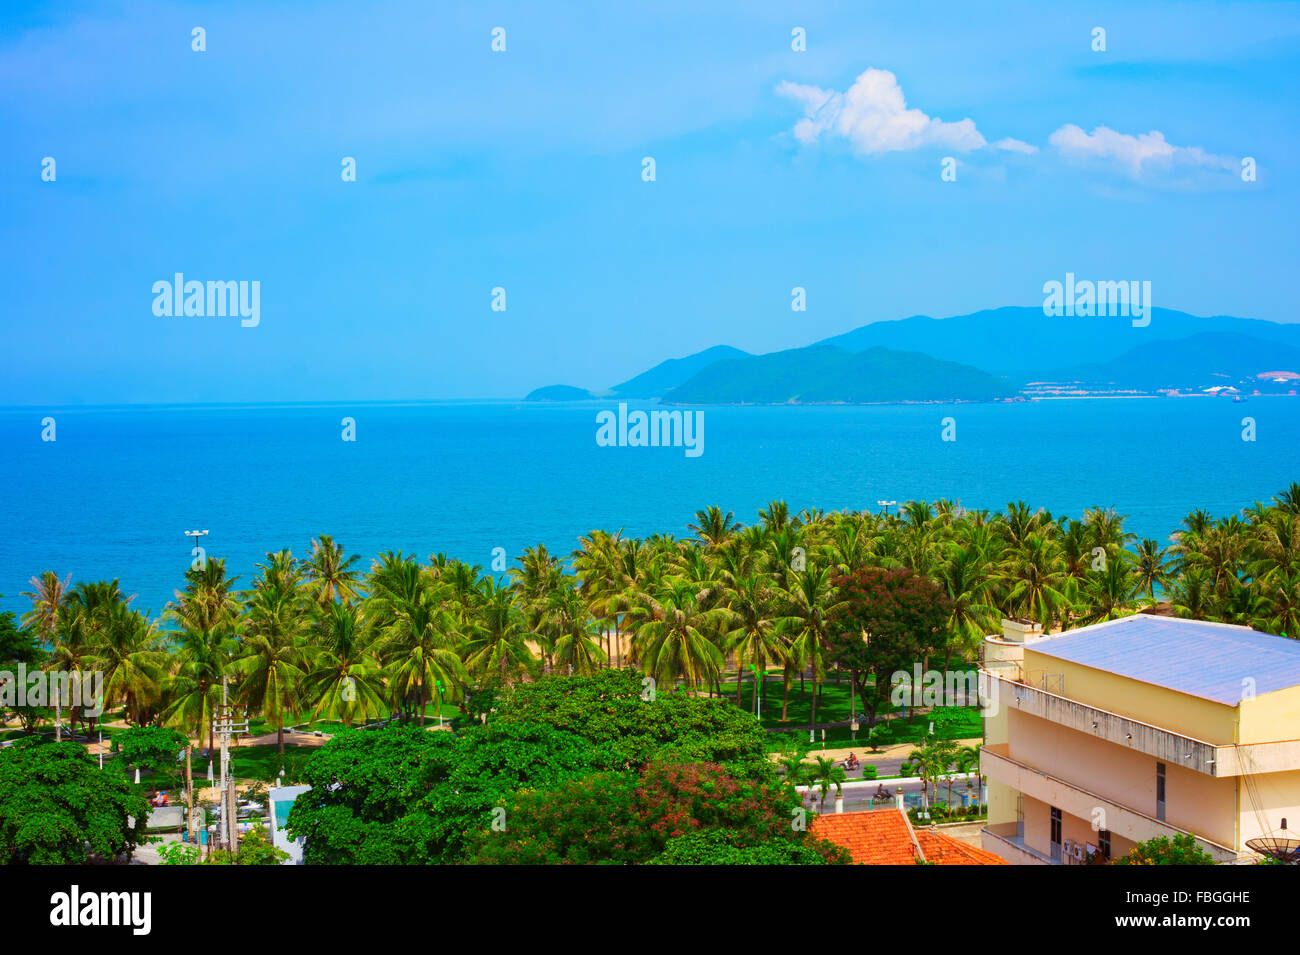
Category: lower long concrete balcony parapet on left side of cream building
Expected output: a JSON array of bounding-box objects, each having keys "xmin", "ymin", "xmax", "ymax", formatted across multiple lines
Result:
[{"xmin": 979, "ymin": 743, "xmax": 1238, "ymax": 863}]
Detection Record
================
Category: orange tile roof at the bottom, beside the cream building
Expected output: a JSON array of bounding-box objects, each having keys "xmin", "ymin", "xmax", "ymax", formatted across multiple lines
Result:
[{"xmin": 813, "ymin": 809, "xmax": 1006, "ymax": 865}]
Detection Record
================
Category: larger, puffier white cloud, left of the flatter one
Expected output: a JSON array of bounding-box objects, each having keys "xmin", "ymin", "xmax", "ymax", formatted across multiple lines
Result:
[{"xmin": 776, "ymin": 69, "xmax": 982, "ymax": 153}]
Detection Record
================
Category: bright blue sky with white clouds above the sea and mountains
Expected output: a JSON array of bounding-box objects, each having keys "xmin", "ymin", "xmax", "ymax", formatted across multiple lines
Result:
[{"xmin": 0, "ymin": 0, "xmax": 1300, "ymax": 407}]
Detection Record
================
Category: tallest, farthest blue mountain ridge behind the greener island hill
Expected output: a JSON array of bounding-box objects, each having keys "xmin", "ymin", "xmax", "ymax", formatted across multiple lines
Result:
[{"xmin": 815, "ymin": 305, "xmax": 1300, "ymax": 381}]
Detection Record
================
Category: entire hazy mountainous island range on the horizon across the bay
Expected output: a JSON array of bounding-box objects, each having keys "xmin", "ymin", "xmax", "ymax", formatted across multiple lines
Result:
[{"xmin": 527, "ymin": 307, "xmax": 1300, "ymax": 404}]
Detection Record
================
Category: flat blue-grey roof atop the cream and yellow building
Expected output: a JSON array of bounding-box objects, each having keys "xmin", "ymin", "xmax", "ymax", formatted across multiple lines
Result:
[{"xmin": 1024, "ymin": 613, "xmax": 1300, "ymax": 707}]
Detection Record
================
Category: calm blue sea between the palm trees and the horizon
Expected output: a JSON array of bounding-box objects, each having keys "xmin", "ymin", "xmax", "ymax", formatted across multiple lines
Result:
[{"xmin": 0, "ymin": 399, "xmax": 1300, "ymax": 612}]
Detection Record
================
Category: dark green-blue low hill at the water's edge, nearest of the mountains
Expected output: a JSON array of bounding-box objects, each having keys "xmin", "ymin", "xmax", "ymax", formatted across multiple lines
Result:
[{"xmin": 663, "ymin": 346, "xmax": 1017, "ymax": 404}]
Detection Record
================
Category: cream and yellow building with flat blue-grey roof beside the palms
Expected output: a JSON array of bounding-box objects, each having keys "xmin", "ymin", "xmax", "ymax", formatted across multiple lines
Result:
[{"xmin": 980, "ymin": 615, "xmax": 1300, "ymax": 864}]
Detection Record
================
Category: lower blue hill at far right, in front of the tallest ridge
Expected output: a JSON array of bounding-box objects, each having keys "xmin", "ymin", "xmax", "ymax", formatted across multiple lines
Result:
[{"xmin": 1047, "ymin": 333, "xmax": 1300, "ymax": 391}]
